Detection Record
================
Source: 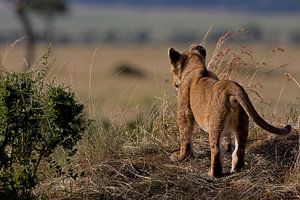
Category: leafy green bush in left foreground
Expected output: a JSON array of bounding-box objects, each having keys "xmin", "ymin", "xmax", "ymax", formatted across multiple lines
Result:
[{"xmin": 0, "ymin": 71, "xmax": 86, "ymax": 199}]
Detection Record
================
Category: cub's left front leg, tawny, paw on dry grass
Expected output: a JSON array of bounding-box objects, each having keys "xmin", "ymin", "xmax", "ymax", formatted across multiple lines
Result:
[{"xmin": 170, "ymin": 109, "xmax": 195, "ymax": 161}]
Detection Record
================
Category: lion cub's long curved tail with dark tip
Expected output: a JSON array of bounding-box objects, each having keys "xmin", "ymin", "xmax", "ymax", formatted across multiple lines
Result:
[{"xmin": 230, "ymin": 82, "xmax": 292, "ymax": 135}]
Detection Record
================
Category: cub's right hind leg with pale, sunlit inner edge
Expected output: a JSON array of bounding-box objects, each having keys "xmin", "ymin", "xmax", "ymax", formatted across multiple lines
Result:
[{"xmin": 230, "ymin": 109, "xmax": 249, "ymax": 173}]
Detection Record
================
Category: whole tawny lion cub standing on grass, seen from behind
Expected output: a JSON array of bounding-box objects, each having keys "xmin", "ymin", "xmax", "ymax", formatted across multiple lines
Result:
[{"xmin": 169, "ymin": 45, "xmax": 291, "ymax": 177}]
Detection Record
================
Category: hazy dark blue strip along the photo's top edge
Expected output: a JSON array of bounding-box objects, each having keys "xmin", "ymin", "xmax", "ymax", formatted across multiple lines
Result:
[{"xmin": 70, "ymin": 0, "xmax": 300, "ymax": 12}]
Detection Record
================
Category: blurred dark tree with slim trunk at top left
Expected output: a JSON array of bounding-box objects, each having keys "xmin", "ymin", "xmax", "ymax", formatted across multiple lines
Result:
[{"xmin": 7, "ymin": 0, "xmax": 67, "ymax": 68}]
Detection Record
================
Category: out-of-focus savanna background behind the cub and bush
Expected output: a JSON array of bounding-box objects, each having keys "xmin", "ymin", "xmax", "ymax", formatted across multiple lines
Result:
[{"xmin": 0, "ymin": 0, "xmax": 300, "ymax": 121}]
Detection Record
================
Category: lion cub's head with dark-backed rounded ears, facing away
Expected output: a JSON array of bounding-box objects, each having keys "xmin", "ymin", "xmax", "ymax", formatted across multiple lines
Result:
[{"xmin": 168, "ymin": 44, "xmax": 206, "ymax": 89}]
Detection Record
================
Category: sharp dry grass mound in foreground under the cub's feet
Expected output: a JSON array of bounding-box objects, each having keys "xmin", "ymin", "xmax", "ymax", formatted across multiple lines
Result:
[{"xmin": 36, "ymin": 98, "xmax": 300, "ymax": 199}]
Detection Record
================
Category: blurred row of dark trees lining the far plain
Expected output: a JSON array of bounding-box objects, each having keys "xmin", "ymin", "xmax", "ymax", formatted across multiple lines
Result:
[{"xmin": 0, "ymin": 24, "xmax": 300, "ymax": 44}]
